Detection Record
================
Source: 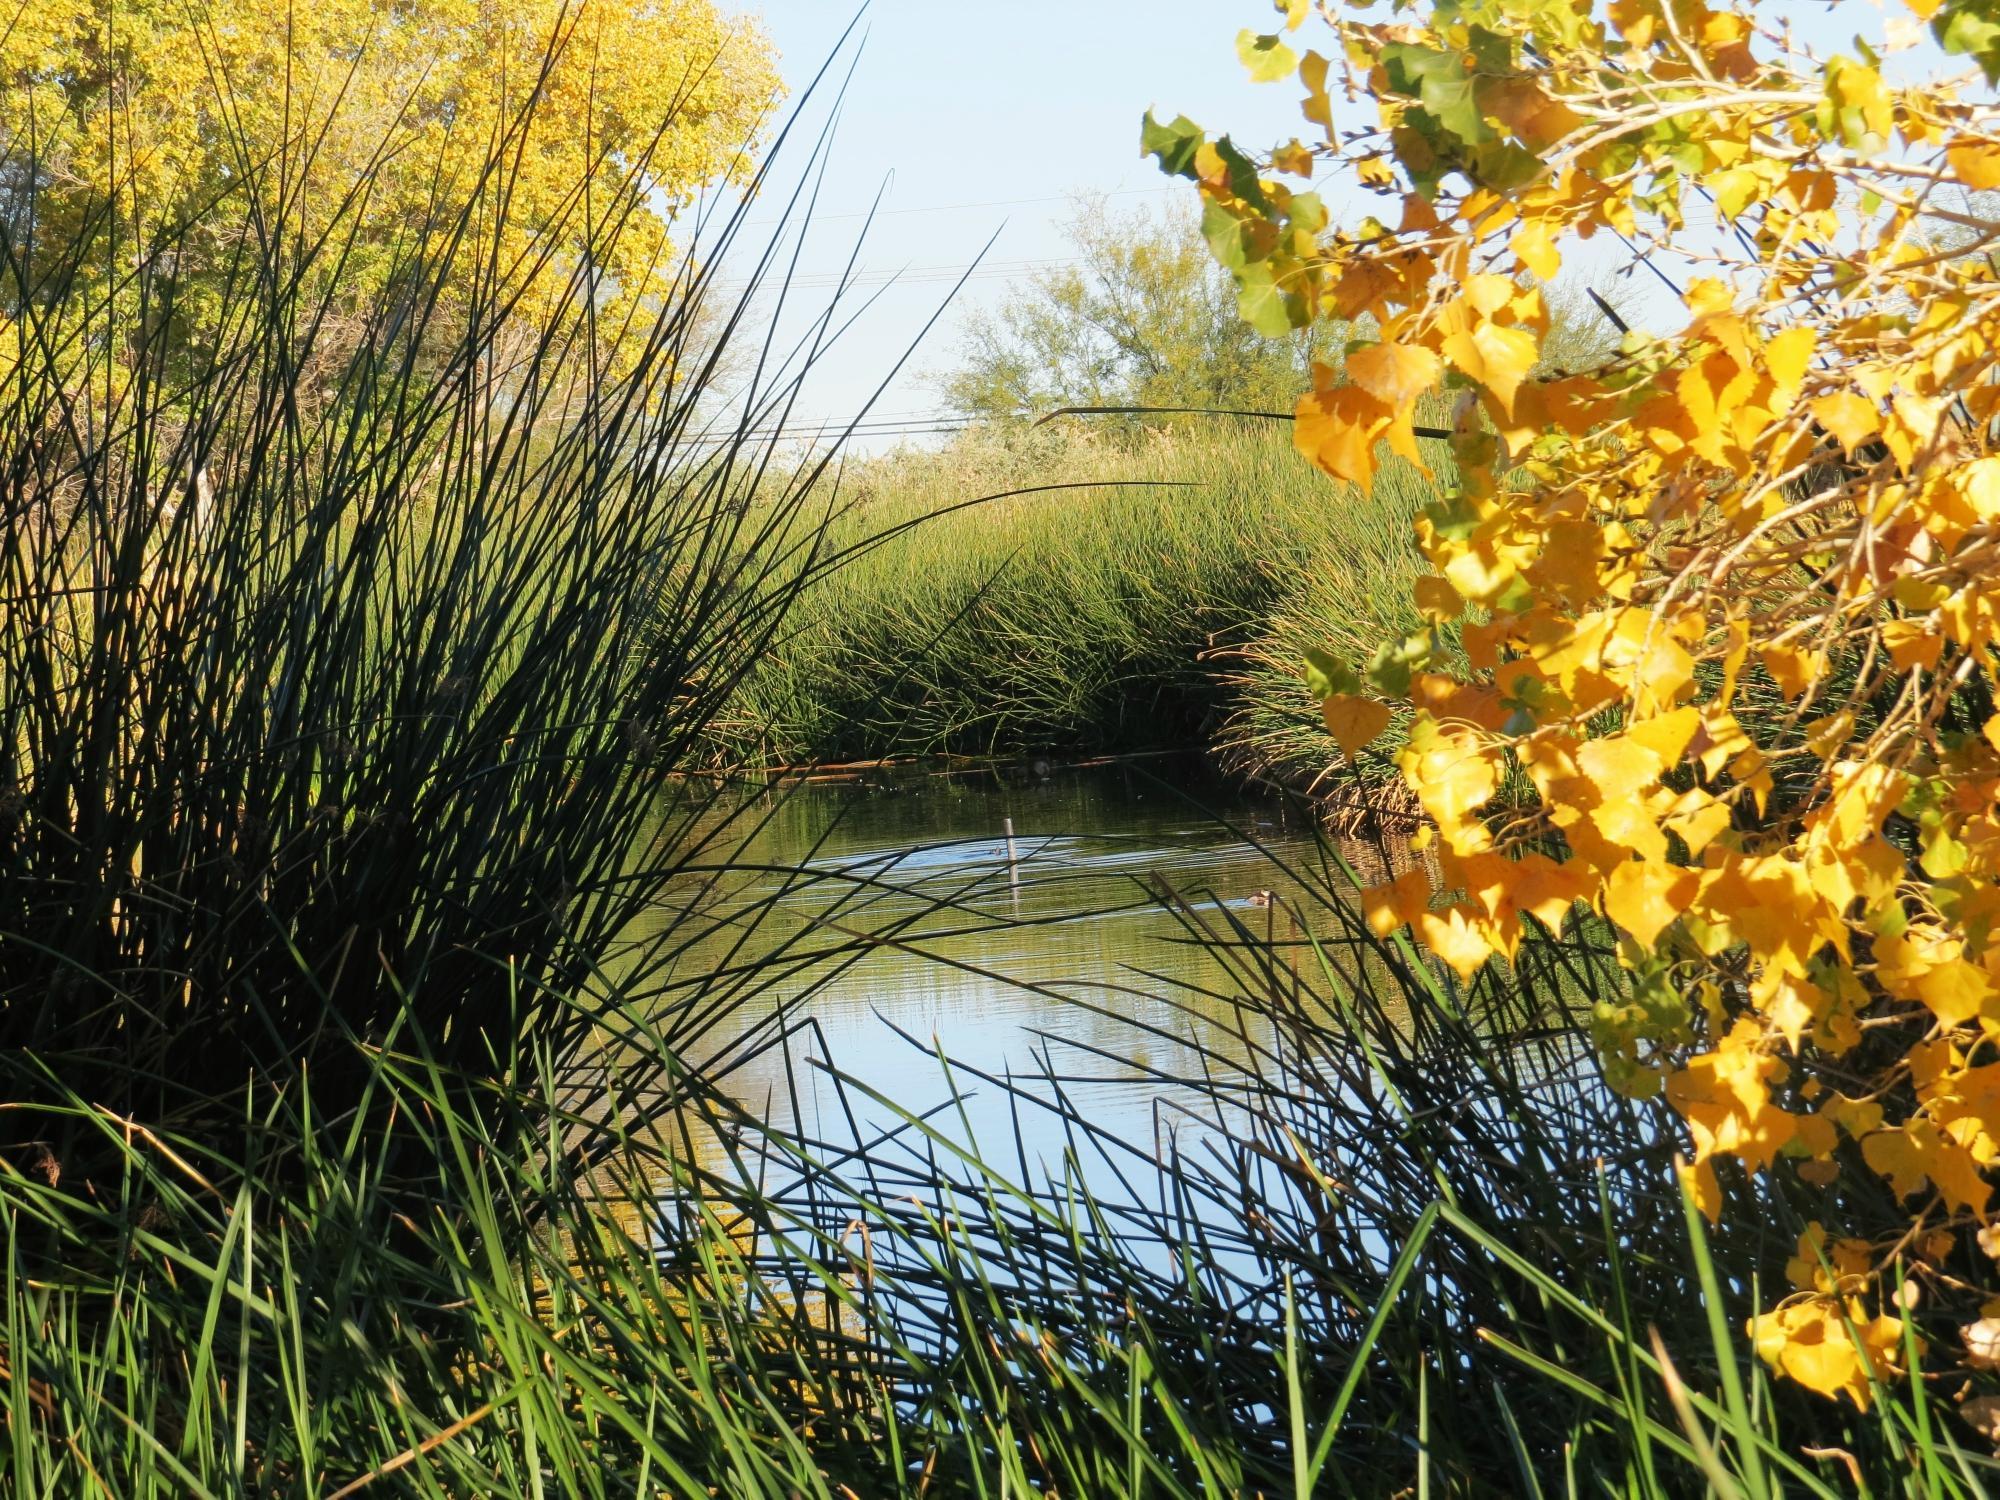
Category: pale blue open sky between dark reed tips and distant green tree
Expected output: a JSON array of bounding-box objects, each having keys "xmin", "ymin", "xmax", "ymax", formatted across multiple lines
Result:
[{"xmin": 712, "ymin": 0, "xmax": 1304, "ymax": 440}]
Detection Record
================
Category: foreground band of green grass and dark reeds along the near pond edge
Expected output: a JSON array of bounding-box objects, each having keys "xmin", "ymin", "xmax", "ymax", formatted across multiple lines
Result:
[{"xmin": 11, "ymin": 816, "xmax": 2000, "ymax": 1496}]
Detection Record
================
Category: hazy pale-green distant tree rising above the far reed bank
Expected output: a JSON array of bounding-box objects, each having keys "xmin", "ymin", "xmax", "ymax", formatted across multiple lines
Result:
[{"xmin": 944, "ymin": 198, "xmax": 1336, "ymax": 422}]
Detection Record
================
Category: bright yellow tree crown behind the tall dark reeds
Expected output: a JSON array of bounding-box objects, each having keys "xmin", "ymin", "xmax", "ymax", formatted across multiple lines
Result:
[{"xmin": 0, "ymin": 0, "xmax": 778, "ymax": 364}]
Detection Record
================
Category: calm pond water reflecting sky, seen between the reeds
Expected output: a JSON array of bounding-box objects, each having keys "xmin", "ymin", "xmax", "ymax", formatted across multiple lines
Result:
[{"xmin": 600, "ymin": 772, "xmax": 1632, "ymax": 1354}]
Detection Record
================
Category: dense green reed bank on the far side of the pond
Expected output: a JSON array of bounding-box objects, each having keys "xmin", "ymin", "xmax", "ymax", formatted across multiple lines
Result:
[{"xmin": 712, "ymin": 422, "xmax": 1430, "ymax": 770}]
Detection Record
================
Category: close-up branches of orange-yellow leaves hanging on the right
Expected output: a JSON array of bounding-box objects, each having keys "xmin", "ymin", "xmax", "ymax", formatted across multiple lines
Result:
[{"xmin": 1162, "ymin": 0, "xmax": 2000, "ymax": 1406}]
